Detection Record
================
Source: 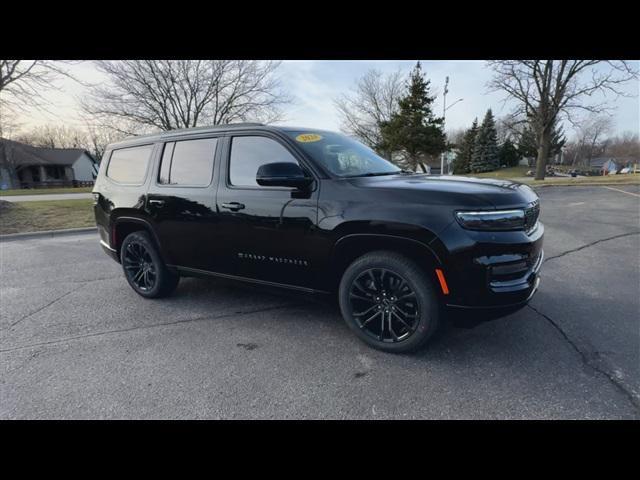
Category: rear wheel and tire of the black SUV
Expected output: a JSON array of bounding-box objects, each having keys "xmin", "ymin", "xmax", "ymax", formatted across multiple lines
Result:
[{"xmin": 120, "ymin": 231, "xmax": 180, "ymax": 298}]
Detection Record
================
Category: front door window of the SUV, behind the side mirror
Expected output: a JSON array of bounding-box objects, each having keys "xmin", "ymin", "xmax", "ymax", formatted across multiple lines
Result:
[{"xmin": 229, "ymin": 137, "xmax": 298, "ymax": 188}]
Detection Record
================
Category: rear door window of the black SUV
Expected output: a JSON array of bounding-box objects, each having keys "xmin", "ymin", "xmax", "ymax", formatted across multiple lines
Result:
[{"xmin": 158, "ymin": 138, "xmax": 218, "ymax": 187}]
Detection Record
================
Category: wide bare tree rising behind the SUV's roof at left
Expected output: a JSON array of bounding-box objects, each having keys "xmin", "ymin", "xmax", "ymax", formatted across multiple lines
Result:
[{"xmin": 82, "ymin": 60, "xmax": 290, "ymax": 134}]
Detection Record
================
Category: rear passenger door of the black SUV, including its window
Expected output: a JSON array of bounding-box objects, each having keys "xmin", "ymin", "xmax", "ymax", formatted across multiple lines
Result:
[{"xmin": 145, "ymin": 136, "xmax": 223, "ymax": 271}]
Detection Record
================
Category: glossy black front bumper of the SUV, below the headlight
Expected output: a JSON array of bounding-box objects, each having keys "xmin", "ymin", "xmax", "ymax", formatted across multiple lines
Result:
[{"xmin": 432, "ymin": 219, "xmax": 544, "ymax": 309}]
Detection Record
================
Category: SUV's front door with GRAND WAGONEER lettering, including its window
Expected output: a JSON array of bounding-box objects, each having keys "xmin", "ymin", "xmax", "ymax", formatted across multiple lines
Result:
[{"xmin": 217, "ymin": 132, "xmax": 320, "ymax": 287}]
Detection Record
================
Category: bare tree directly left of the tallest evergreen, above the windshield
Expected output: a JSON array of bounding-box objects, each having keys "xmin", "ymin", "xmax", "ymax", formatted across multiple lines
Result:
[{"xmin": 334, "ymin": 70, "xmax": 405, "ymax": 155}]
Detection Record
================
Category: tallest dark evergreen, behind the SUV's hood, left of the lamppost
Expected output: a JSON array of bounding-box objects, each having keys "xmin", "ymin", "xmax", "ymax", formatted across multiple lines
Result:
[{"xmin": 380, "ymin": 62, "xmax": 446, "ymax": 171}]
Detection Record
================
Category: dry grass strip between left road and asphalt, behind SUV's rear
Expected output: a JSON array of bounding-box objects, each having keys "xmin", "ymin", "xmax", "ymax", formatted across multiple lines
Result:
[{"xmin": 0, "ymin": 200, "xmax": 95, "ymax": 235}]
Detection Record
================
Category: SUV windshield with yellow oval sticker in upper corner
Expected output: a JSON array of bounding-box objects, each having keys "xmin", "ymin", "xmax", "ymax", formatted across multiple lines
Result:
[{"xmin": 286, "ymin": 131, "xmax": 402, "ymax": 177}]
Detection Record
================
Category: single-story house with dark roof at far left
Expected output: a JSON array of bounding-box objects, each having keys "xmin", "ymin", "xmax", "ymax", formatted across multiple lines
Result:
[{"xmin": 0, "ymin": 138, "xmax": 98, "ymax": 190}]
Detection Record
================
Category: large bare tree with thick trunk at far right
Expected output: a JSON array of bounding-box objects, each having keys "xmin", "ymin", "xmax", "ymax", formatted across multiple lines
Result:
[{"xmin": 489, "ymin": 60, "xmax": 638, "ymax": 180}]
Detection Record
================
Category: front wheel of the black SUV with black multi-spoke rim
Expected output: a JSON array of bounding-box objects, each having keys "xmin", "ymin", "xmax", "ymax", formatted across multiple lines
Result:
[{"xmin": 338, "ymin": 251, "xmax": 440, "ymax": 353}]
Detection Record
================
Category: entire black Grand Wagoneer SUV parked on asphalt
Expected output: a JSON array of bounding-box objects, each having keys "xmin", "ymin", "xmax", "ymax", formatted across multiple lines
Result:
[{"xmin": 93, "ymin": 124, "xmax": 544, "ymax": 352}]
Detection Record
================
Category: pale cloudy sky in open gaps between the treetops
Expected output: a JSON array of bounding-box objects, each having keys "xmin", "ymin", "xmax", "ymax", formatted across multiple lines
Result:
[{"xmin": 10, "ymin": 60, "xmax": 640, "ymax": 138}]
